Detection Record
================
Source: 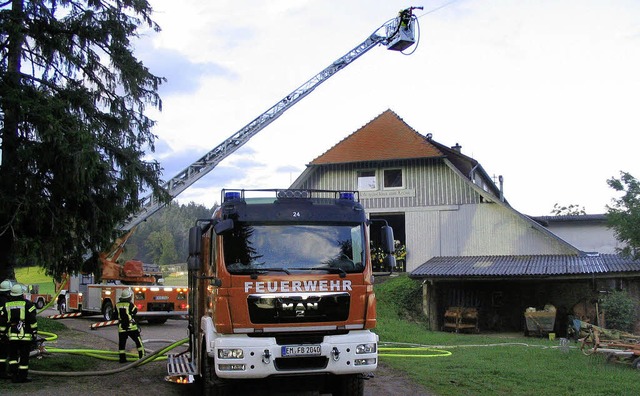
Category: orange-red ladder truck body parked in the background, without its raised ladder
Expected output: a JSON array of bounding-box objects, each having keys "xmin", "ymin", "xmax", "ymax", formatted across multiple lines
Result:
[{"xmin": 57, "ymin": 227, "xmax": 189, "ymax": 324}]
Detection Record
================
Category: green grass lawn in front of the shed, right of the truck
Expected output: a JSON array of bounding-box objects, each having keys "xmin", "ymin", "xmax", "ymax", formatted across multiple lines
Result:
[{"xmin": 375, "ymin": 277, "xmax": 640, "ymax": 396}]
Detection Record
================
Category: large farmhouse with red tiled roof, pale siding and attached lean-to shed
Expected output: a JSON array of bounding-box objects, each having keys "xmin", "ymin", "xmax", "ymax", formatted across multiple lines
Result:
[{"xmin": 291, "ymin": 110, "xmax": 640, "ymax": 335}]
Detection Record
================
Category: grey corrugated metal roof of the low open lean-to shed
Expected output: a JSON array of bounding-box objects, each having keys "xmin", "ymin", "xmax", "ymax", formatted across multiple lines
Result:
[{"xmin": 410, "ymin": 254, "xmax": 640, "ymax": 278}]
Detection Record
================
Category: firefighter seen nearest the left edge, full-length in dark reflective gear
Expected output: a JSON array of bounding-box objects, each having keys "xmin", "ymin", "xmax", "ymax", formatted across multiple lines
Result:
[{"xmin": 4, "ymin": 283, "xmax": 38, "ymax": 382}]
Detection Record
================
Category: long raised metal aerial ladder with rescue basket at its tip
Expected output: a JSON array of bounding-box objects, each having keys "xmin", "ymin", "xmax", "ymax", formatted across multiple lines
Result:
[{"xmin": 119, "ymin": 7, "xmax": 423, "ymax": 231}]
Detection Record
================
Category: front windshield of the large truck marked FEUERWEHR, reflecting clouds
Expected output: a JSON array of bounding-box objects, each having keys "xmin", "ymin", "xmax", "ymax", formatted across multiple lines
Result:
[{"xmin": 223, "ymin": 223, "xmax": 364, "ymax": 274}]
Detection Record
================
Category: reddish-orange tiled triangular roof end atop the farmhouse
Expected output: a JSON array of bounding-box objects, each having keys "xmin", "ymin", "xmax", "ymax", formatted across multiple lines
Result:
[{"xmin": 311, "ymin": 110, "xmax": 444, "ymax": 165}]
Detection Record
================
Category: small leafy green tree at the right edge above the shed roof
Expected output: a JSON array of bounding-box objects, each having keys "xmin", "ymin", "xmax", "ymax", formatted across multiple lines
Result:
[{"xmin": 607, "ymin": 172, "xmax": 640, "ymax": 259}]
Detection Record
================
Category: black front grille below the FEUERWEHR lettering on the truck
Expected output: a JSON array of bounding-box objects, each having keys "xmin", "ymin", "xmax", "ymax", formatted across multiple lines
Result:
[{"xmin": 247, "ymin": 293, "xmax": 351, "ymax": 324}]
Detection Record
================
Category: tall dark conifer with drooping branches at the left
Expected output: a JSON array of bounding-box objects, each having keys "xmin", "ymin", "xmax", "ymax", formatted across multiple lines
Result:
[{"xmin": 0, "ymin": 0, "xmax": 168, "ymax": 279}]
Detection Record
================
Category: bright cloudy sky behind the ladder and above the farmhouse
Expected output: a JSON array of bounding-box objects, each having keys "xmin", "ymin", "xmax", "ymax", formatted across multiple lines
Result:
[{"xmin": 135, "ymin": 0, "xmax": 640, "ymax": 216}]
